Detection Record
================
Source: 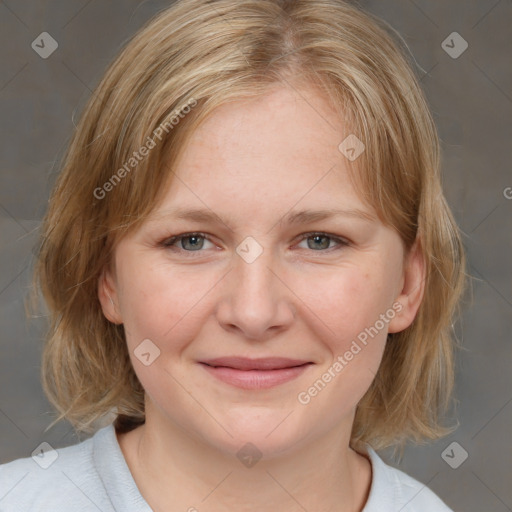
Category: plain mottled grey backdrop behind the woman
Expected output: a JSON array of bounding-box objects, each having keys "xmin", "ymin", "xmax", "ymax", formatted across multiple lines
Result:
[{"xmin": 0, "ymin": 0, "xmax": 512, "ymax": 512}]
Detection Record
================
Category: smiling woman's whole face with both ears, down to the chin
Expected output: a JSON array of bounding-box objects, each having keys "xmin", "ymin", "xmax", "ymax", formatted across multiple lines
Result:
[{"xmin": 99, "ymin": 86, "xmax": 423, "ymax": 453}]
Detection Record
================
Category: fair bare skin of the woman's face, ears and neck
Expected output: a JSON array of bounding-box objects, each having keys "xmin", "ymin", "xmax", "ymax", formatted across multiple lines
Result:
[{"xmin": 99, "ymin": 82, "xmax": 424, "ymax": 512}]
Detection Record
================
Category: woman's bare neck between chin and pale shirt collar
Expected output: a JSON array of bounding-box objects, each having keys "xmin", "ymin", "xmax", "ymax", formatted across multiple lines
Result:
[{"xmin": 118, "ymin": 411, "xmax": 371, "ymax": 512}]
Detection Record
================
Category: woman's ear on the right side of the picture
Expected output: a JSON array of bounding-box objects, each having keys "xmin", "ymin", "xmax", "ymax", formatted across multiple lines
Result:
[{"xmin": 388, "ymin": 236, "xmax": 425, "ymax": 333}]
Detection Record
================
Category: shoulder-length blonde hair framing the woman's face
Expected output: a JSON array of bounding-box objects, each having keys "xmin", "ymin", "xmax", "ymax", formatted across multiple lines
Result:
[{"xmin": 35, "ymin": 0, "xmax": 465, "ymax": 449}]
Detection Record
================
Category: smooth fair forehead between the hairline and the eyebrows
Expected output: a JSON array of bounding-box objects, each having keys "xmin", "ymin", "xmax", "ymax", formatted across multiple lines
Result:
[{"xmin": 155, "ymin": 86, "xmax": 371, "ymax": 220}]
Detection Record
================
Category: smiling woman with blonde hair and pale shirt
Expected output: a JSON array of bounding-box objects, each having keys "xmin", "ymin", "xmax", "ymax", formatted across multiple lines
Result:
[{"xmin": 0, "ymin": 0, "xmax": 465, "ymax": 512}]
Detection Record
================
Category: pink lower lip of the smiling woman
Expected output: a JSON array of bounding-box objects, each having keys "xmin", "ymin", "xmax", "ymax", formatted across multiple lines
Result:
[{"xmin": 200, "ymin": 363, "xmax": 311, "ymax": 389}]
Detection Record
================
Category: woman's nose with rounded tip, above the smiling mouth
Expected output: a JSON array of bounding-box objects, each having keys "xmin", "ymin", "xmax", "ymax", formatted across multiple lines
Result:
[{"xmin": 216, "ymin": 242, "xmax": 296, "ymax": 341}]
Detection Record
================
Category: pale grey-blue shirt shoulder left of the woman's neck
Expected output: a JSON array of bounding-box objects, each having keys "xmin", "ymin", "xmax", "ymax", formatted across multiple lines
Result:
[{"xmin": 0, "ymin": 426, "xmax": 111, "ymax": 512}]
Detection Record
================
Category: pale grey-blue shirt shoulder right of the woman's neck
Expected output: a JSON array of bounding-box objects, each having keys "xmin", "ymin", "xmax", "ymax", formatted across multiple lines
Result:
[{"xmin": 363, "ymin": 445, "xmax": 453, "ymax": 512}]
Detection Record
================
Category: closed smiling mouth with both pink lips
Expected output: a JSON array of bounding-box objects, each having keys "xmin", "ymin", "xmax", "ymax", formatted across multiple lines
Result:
[{"xmin": 199, "ymin": 357, "xmax": 314, "ymax": 390}]
